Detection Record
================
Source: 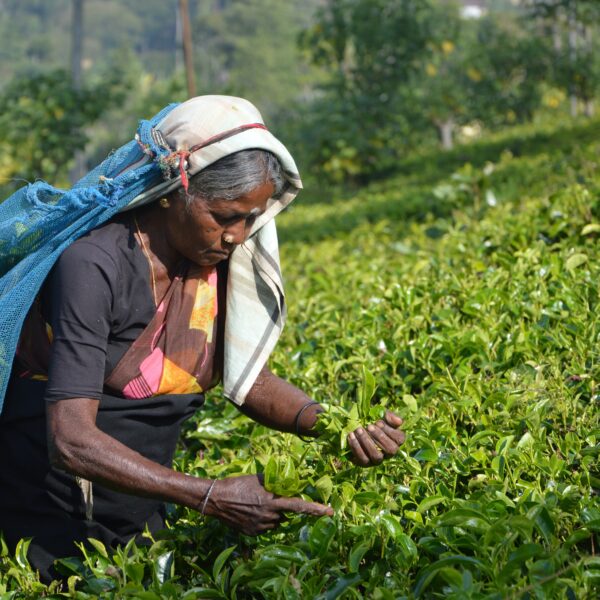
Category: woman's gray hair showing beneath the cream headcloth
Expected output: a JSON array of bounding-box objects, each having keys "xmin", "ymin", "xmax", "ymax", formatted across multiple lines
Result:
[{"xmin": 186, "ymin": 150, "xmax": 287, "ymax": 206}]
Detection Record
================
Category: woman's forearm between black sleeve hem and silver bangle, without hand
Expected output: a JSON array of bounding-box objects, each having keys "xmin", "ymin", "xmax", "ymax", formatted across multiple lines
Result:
[{"xmin": 48, "ymin": 398, "xmax": 211, "ymax": 510}]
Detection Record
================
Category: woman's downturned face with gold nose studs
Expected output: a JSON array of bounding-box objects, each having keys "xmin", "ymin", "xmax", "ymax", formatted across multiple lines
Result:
[{"xmin": 164, "ymin": 182, "xmax": 274, "ymax": 266}]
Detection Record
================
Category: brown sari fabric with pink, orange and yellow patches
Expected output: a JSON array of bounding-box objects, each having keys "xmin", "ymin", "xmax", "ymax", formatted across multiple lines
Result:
[{"xmin": 17, "ymin": 263, "xmax": 220, "ymax": 399}]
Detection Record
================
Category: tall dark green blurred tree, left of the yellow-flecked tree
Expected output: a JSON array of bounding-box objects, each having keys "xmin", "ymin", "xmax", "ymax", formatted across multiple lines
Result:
[{"xmin": 300, "ymin": 0, "xmax": 430, "ymax": 181}]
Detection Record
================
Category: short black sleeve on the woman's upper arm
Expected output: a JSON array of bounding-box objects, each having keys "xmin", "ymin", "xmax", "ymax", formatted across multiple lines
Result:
[{"xmin": 44, "ymin": 240, "xmax": 119, "ymax": 401}]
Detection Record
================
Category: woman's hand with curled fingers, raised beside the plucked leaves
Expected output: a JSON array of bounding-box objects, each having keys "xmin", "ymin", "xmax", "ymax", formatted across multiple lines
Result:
[{"xmin": 348, "ymin": 410, "xmax": 406, "ymax": 467}]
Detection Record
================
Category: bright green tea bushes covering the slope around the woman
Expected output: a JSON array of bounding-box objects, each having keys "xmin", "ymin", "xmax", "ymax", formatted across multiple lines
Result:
[{"xmin": 0, "ymin": 116, "xmax": 600, "ymax": 600}]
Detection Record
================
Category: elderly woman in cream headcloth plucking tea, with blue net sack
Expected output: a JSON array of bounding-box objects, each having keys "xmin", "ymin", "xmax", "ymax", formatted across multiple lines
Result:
[{"xmin": 0, "ymin": 96, "xmax": 404, "ymax": 580}]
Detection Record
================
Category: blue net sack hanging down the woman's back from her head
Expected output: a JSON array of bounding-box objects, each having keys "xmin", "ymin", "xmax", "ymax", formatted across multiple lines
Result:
[{"xmin": 0, "ymin": 104, "xmax": 177, "ymax": 412}]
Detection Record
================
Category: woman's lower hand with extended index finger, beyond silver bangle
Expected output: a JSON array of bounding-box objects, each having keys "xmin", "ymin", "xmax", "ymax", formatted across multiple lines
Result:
[{"xmin": 204, "ymin": 475, "xmax": 333, "ymax": 535}]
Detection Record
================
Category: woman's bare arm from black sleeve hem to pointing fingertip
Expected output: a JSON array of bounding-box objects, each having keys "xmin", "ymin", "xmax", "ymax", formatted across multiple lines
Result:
[{"xmin": 48, "ymin": 398, "xmax": 333, "ymax": 535}]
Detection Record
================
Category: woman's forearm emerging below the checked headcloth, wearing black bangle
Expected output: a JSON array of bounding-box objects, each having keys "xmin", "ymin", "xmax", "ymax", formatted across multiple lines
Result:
[{"xmin": 239, "ymin": 367, "xmax": 322, "ymax": 436}]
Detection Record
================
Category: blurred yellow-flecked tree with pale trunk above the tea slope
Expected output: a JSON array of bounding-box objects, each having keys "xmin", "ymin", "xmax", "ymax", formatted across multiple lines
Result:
[{"xmin": 411, "ymin": 3, "xmax": 547, "ymax": 149}]
